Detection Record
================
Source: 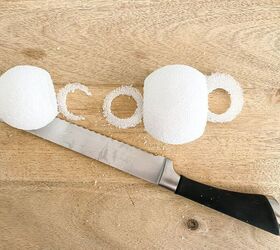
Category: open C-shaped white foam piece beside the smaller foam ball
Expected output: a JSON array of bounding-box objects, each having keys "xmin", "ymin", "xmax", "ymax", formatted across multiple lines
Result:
[{"xmin": 57, "ymin": 83, "xmax": 92, "ymax": 121}]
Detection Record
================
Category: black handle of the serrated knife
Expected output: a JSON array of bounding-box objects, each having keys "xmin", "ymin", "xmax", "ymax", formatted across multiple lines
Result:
[{"xmin": 175, "ymin": 176, "xmax": 279, "ymax": 235}]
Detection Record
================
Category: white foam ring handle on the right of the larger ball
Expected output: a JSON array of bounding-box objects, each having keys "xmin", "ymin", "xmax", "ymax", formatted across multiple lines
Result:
[{"xmin": 207, "ymin": 73, "xmax": 244, "ymax": 123}]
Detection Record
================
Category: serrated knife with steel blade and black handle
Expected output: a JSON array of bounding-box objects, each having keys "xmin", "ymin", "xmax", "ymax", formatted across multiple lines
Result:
[{"xmin": 28, "ymin": 118, "xmax": 280, "ymax": 235}]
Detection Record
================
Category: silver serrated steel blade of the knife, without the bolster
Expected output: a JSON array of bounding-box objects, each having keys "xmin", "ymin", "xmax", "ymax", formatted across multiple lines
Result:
[{"xmin": 28, "ymin": 118, "xmax": 166, "ymax": 184}]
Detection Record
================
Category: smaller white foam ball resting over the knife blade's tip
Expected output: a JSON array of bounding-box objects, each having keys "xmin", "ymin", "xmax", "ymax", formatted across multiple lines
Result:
[{"xmin": 0, "ymin": 65, "xmax": 58, "ymax": 130}]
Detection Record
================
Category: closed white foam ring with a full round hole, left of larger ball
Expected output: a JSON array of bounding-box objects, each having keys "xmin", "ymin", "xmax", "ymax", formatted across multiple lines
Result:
[{"xmin": 103, "ymin": 86, "xmax": 143, "ymax": 129}]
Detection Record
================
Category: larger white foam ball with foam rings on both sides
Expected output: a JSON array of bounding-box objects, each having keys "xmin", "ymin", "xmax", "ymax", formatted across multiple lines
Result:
[{"xmin": 143, "ymin": 65, "xmax": 208, "ymax": 144}]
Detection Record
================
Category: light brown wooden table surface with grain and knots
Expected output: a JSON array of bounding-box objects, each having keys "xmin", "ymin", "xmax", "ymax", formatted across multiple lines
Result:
[{"xmin": 0, "ymin": 0, "xmax": 280, "ymax": 250}]
